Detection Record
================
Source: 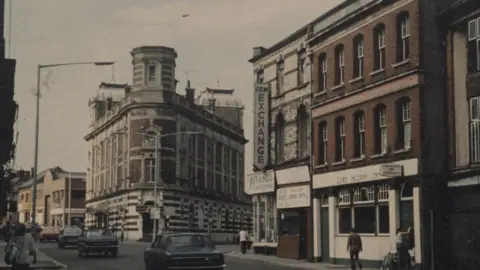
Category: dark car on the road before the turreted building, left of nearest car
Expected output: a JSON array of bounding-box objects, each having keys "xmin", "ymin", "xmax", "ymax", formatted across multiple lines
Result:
[{"xmin": 77, "ymin": 228, "xmax": 118, "ymax": 257}]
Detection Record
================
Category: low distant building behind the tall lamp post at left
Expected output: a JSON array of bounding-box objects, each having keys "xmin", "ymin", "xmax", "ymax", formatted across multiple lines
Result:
[{"xmin": 15, "ymin": 167, "xmax": 86, "ymax": 227}]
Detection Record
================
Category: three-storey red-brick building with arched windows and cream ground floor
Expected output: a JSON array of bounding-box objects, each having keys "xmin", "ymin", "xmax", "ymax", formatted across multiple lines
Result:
[{"xmin": 308, "ymin": 0, "xmax": 446, "ymax": 269}]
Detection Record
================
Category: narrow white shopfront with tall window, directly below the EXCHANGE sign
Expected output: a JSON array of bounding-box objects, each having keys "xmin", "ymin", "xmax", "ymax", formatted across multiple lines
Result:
[{"xmin": 245, "ymin": 170, "xmax": 278, "ymax": 254}]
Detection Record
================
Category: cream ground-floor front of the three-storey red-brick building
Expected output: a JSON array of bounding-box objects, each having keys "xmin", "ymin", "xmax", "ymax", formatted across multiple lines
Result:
[{"xmin": 312, "ymin": 159, "xmax": 421, "ymax": 268}]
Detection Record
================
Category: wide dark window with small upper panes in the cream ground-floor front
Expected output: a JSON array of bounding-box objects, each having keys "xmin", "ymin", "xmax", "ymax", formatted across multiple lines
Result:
[{"xmin": 337, "ymin": 184, "xmax": 390, "ymax": 234}]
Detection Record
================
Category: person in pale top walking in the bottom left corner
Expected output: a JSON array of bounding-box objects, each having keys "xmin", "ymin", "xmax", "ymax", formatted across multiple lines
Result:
[{"xmin": 5, "ymin": 224, "xmax": 37, "ymax": 270}]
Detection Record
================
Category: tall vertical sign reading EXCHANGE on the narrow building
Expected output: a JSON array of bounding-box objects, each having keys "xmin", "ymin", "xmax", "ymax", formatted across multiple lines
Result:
[{"xmin": 253, "ymin": 83, "xmax": 270, "ymax": 170}]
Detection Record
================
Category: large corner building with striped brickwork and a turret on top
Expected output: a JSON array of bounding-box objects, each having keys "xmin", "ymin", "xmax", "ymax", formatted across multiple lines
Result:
[{"xmin": 85, "ymin": 46, "xmax": 251, "ymax": 242}]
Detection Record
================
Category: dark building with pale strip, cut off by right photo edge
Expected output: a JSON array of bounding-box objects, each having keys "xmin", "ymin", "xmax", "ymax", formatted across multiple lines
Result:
[{"xmin": 438, "ymin": 1, "xmax": 480, "ymax": 269}]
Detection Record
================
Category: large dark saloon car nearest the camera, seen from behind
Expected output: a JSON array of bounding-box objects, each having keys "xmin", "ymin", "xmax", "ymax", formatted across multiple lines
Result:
[{"xmin": 143, "ymin": 233, "xmax": 226, "ymax": 270}]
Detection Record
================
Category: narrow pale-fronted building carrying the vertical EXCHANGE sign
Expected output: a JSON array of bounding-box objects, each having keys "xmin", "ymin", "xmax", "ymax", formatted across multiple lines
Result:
[{"xmin": 246, "ymin": 26, "xmax": 313, "ymax": 259}]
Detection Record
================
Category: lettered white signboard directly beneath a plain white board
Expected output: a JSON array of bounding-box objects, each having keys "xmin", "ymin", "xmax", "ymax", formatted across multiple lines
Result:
[{"xmin": 277, "ymin": 185, "xmax": 310, "ymax": 209}]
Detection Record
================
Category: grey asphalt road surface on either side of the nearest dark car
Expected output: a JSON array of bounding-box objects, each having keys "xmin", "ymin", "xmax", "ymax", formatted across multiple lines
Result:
[{"xmin": 38, "ymin": 242, "xmax": 292, "ymax": 270}]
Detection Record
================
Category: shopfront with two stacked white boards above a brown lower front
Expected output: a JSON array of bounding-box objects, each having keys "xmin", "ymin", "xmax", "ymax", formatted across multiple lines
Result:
[{"xmin": 275, "ymin": 166, "xmax": 312, "ymax": 260}]
